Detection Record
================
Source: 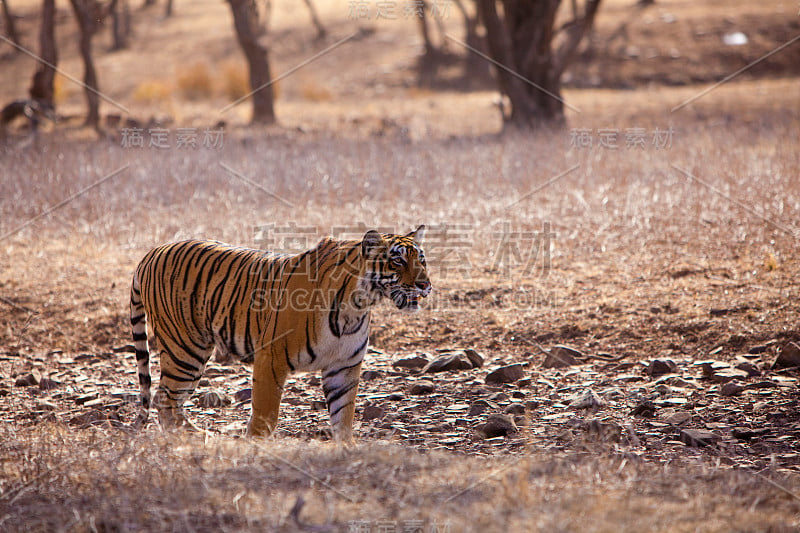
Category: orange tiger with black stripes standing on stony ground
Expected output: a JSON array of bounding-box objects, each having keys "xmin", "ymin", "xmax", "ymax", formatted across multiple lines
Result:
[{"xmin": 130, "ymin": 225, "xmax": 432, "ymax": 443}]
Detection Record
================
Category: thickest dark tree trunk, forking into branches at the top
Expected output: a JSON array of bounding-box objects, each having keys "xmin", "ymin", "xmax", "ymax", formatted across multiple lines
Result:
[{"xmin": 477, "ymin": 0, "xmax": 600, "ymax": 128}]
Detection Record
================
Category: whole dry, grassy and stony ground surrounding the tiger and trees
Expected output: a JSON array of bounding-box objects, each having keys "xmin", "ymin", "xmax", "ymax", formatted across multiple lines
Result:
[{"xmin": 0, "ymin": 1, "xmax": 800, "ymax": 531}]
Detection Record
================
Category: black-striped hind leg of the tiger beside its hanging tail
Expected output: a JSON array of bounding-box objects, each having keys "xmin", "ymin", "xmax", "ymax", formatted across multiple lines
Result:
[{"xmin": 153, "ymin": 343, "xmax": 212, "ymax": 431}]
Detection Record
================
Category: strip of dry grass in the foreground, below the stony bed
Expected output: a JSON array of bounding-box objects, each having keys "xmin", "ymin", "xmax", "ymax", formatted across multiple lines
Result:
[{"xmin": 0, "ymin": 424, "xmax": 800, "ymax": 532}]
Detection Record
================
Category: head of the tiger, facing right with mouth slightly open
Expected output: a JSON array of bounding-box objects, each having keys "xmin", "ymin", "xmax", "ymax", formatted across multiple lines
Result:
[{"xmin": 361, "ymin": 226, "xmax": 432, "ymax": 312}]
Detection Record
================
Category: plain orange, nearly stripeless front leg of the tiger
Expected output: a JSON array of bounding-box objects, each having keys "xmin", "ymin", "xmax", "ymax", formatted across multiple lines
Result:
[{"xmin": 247, "ymin": 352, "xmax": 289, "ymax": 437}]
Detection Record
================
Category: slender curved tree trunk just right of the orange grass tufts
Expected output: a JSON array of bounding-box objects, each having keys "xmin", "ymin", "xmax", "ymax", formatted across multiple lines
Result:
[{"xmin": 228, "ymin": 0, "xmax": 275, "ymax": 124}]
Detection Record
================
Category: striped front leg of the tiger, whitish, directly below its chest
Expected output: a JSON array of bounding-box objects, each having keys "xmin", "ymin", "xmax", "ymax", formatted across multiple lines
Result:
[{"xmin": 322, "ymin": 358, "xmax": 361, "ymax": 444}]
